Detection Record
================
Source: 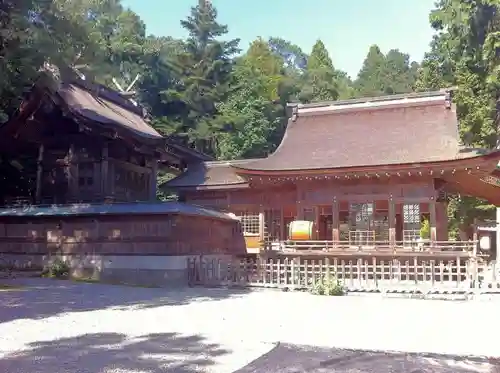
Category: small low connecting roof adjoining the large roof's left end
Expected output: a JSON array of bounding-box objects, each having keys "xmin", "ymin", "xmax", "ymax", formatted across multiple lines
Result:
[{"xmin": 162, "ymin": 159, "xmax": 253, "ymax": 189}]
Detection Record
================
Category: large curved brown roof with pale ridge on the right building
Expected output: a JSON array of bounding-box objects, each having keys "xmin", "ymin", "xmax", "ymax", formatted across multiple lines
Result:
[{"xmin": 235, "ymin": 92, "xmax": 484, "ymax": 171}]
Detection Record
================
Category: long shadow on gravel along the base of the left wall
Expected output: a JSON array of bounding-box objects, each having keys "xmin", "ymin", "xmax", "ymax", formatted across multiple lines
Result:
[{"xmin": 0, "ymin": 278, "xmax": 250, "ymax": 323}]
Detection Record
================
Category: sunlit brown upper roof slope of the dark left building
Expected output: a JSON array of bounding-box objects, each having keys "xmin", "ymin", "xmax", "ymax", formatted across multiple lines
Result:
[{"xmin": 57, "ymin": 84, "xmax": 163, "ymax": 139}]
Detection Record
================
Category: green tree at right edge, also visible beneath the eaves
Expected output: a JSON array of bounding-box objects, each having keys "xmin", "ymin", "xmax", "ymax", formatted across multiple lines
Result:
[{"xmin": 417, "ymin": 0, "xmax": 500, "ymax": 233}]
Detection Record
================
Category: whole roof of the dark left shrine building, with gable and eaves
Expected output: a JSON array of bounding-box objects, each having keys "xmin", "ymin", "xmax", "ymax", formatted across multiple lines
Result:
[{"xmin": 0, "ymin": 70, "xmax": 211, "ymax": 162}]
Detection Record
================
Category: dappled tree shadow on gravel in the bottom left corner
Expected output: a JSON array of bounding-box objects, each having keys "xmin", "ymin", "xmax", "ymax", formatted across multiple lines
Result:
[{"xmin": 0, "ymin": 333, "xmax": 230, "ymax": 373}]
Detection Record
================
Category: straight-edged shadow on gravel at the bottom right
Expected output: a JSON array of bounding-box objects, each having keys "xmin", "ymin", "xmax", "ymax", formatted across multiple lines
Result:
[{"xmin": 235, "ymin": 344, "xmax": 500, "ymax": 373}]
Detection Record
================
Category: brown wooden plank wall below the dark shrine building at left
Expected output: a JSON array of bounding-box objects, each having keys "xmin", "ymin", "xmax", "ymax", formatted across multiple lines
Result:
[{"xmin": 0, "ymin": 214, "xmax": 246, "ymax": 256}]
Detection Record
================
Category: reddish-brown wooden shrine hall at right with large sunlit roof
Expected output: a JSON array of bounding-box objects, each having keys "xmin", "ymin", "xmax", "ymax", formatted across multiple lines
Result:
[{"xmin": 166, "ymin": 91, "xmax": 500, "ymax": 252}]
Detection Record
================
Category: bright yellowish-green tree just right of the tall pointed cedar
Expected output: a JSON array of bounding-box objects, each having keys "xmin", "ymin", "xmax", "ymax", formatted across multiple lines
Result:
[{"xmin": 218, "ymin": 38, "xmax": 284, "ymax": 159}]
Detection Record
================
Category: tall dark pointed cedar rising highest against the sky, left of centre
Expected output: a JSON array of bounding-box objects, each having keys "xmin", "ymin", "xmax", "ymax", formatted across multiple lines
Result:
[{"xmin": 177, "ymin": 0, "xmax": 239, "ymax": 154}]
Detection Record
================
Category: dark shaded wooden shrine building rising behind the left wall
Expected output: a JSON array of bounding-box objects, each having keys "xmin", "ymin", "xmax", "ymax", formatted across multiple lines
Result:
[{"xmin": 0, "ymin": 69, "xmax": 210, "ymax": 205}]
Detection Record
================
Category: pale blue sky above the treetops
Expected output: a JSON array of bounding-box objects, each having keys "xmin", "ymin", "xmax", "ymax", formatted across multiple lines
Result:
[{"xmin": 122, "ymin": 0, "xmax": 435, "ymax": 78}]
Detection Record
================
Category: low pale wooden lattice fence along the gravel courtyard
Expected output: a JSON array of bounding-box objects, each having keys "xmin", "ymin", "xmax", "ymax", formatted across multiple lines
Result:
[{"xmin": 188, "ymin": 257, "xmax": 500, "ymax": 293}]
